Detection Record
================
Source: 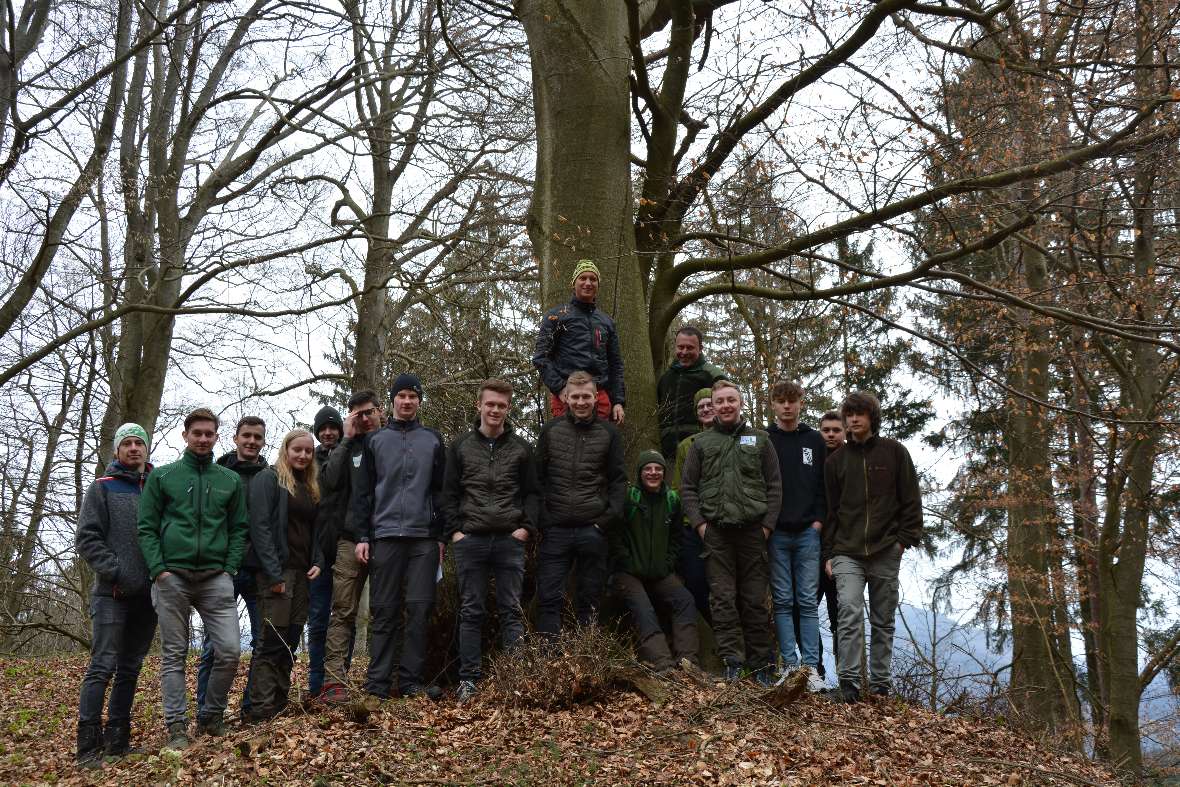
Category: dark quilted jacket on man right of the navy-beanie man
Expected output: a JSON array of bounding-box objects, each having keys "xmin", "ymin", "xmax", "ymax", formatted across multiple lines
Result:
[{"xmin": 443, "ymin": 422, "xmax": 540, "ymax": 539}]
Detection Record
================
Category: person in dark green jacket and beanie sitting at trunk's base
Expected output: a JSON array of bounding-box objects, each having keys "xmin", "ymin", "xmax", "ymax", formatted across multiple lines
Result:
[{"xmin": 609, "ymin": 451, "xmax": 697, "ymax": 673}]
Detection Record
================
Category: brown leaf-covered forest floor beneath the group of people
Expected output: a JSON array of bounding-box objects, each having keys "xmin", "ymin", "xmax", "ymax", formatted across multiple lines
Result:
[{"xmin": 0, "ymin": 655, "xmax": 1114, "ymax": 787}]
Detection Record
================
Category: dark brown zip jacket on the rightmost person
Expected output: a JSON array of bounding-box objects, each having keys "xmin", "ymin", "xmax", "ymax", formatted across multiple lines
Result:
[{"xmin": 822, "ymin": 434, "xmax": 923, "ymax": 560}]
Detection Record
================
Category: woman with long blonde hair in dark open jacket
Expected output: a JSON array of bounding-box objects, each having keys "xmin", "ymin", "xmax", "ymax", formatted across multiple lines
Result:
[{"xmin": 247, "ymin": 429, "xmax": 325, "ymax": 721}]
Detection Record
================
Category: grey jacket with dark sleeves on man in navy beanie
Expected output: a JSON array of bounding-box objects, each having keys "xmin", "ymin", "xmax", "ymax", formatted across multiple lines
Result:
[{"xmin": 352, "ymin": 418, "xmax": 446, "ymax": 543}]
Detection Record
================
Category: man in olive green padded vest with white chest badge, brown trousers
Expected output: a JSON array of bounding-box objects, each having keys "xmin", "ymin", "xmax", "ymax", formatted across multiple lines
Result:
[{"xmin": 681, "ymin": 380, "xmax": 782, "ymax": 686}]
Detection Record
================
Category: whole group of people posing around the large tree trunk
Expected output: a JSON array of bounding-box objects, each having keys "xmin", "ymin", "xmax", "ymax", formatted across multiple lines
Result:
[{"xmin": 77, "ymin": 261, "xmax": 922, "ymax": 767}]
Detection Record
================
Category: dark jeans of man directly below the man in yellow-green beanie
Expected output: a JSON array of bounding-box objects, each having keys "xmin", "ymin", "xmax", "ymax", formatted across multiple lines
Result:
[{"xmin": 537, "ymin": 525, "xmax": 607, "ymax": 636}]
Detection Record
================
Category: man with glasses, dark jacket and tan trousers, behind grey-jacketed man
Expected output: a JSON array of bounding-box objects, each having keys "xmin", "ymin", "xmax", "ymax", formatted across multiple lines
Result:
[{"xmin": 320, "ymin": 389, "xmax": 381, "ymax": 703}]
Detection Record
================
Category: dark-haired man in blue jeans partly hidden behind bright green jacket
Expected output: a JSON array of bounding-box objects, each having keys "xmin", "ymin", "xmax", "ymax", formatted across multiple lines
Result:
[{"xmin": 197, "ymin": 415, "xmax": 267, "ymax": 717}]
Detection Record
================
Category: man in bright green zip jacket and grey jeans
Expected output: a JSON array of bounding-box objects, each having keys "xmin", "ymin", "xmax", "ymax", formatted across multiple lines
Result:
[{"xmin": 137, "ymin": 407, "xmax": 249, "ymax": 749}]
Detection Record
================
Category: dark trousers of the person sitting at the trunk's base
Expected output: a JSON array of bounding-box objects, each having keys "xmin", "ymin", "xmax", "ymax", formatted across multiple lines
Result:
[{"xmin": 614, "ymin": 572, "xmax": 699, "ymax": 671}]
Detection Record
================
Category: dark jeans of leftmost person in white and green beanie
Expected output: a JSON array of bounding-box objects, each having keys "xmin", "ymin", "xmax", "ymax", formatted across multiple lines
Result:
[{"xmin": 78, "ymin": 596, "xmax": 156, "ymax": 728}]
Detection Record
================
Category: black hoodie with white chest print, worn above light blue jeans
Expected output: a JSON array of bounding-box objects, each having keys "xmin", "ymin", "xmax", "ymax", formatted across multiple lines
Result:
[{"xmin": 766, "ymin": 424, "xmax": 827, "ymax": 533}]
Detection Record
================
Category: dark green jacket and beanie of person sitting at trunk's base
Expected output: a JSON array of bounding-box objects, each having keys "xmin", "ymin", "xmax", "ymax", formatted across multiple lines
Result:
[{"xmin": 608, "ymin": 451, "xmax": 684, "ymax": 579}]
